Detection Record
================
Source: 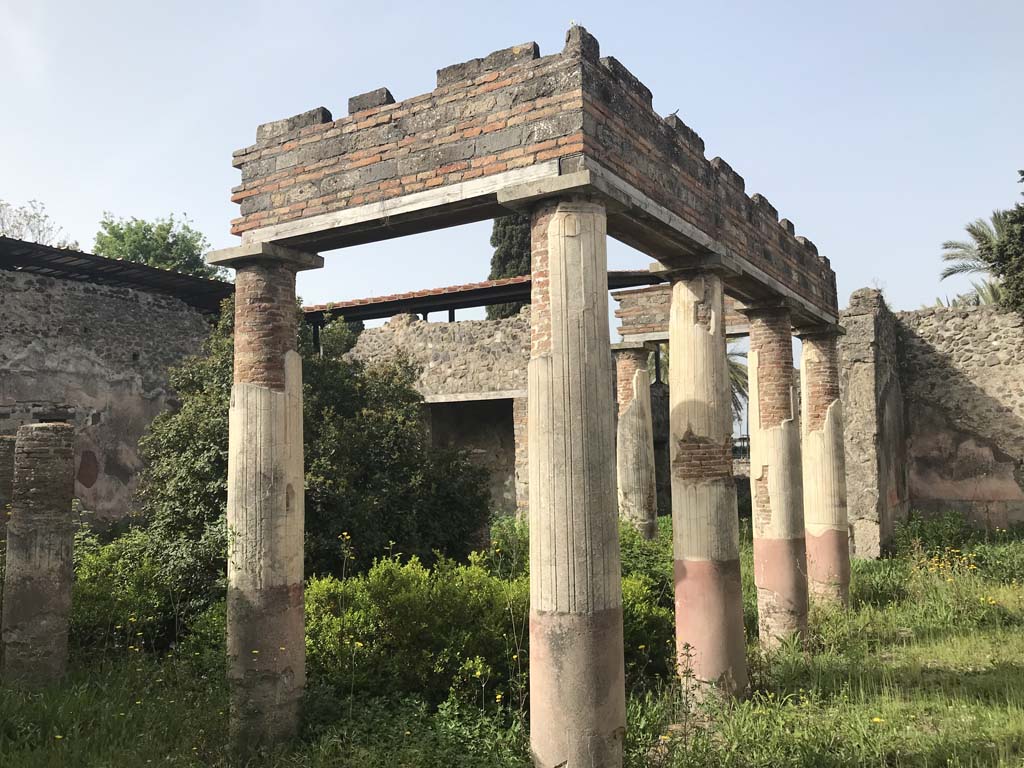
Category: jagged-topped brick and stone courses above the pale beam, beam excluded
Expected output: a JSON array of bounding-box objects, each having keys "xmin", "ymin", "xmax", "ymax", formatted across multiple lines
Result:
[{"xmin": 231, "ymin": 27, "xmax": 837, "ymax": 313}]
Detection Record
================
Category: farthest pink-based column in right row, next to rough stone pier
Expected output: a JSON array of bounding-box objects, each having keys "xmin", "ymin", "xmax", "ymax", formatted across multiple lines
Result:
[{"xmin": 800, "ymin": 327, "xmax": 850, "ymax": 605}]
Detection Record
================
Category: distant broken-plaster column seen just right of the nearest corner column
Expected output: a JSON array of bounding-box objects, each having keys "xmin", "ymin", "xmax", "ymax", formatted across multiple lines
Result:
[{"xmin": 612, "ymin": 342, "xmax": 657, "ymax": 539}]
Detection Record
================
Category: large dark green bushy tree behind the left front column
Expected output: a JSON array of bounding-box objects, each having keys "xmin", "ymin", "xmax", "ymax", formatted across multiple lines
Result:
[{"xmin": 139, "ymin": 300, "xmax": 489, "ymax": 614}]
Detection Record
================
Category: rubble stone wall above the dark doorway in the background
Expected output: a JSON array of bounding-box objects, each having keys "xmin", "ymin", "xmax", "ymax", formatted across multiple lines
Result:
[{"xmin": 349, "ymin": 308, "xmax": 529, "ymax": 400}]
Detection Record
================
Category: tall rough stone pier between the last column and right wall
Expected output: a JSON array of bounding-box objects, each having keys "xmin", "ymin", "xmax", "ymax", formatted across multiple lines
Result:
[{"xmin": 840, "ymin": 288, "xmax": 908, "ymax": 557}]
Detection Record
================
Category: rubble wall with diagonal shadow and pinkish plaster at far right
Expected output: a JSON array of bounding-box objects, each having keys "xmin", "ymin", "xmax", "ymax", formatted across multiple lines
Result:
[{"xmin": 896, "ymin": 307, "xmax": 1024, "ymax": 526}]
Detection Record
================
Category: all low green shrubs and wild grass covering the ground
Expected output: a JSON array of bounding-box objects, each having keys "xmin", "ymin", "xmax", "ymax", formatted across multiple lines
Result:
[{"xmin": 0, "ymin": 515, "xmax": 1024, "ymax": 768}]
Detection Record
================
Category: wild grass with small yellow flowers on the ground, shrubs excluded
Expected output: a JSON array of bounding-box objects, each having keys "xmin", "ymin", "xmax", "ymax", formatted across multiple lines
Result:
[{"xmin": 0, "ymin": 520, "xmax": 1024, "ymax": 768}]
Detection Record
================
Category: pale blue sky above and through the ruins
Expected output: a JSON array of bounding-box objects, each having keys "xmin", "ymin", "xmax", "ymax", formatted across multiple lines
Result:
[{"xmin": 0, "ymin": 0, "xmax": 1024, "ymax": 308}]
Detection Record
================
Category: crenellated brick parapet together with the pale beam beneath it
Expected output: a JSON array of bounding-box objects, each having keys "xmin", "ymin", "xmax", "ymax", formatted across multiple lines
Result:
[{"xmin": 232, "ymin": 27, "xmax": 838, "ymax": 322}]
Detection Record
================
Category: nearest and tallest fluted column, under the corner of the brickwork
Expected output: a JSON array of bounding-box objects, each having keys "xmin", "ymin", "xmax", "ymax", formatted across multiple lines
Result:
[{"xmin": 528, "ymin": 200, "xmax": 626, "ymax": 768}]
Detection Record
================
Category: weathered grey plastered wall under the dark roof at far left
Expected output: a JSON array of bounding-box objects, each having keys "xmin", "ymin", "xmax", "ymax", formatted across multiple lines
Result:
[{"xmin": 0, "ymin": 271, "xmax": 209, "ymax": 517}]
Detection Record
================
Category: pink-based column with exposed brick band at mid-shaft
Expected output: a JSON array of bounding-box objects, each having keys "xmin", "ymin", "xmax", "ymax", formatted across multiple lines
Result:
[{"xmin": 669, "ymin": 272, "xmax": 746, "ymax": 694}]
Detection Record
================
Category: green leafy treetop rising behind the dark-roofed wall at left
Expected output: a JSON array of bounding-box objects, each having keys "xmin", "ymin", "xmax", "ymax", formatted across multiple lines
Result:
[{"xmin": 92, "ymin": 212, "xmax": 226, "ymax": 280}]
